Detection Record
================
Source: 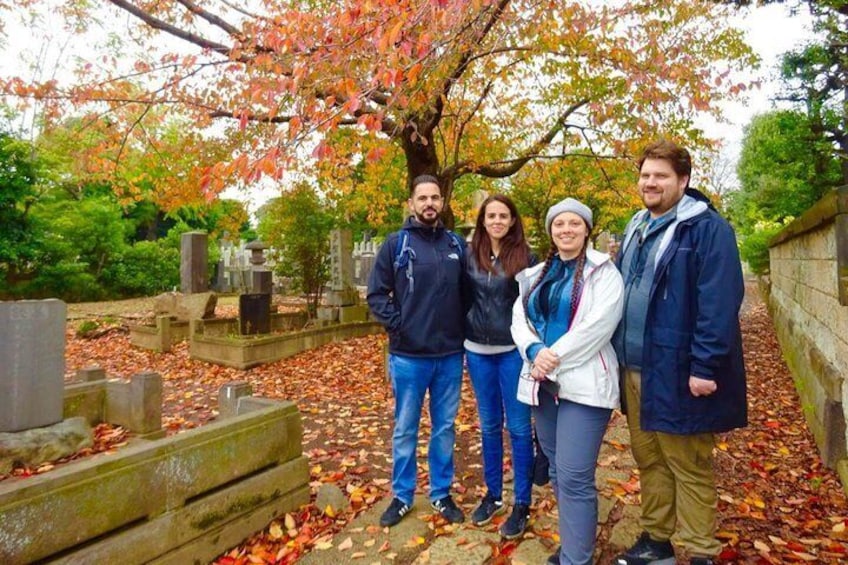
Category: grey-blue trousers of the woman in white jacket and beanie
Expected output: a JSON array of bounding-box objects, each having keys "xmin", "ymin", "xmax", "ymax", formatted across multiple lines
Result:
[{"xmin": 533, "ymin": 393, "xmax": 612, "ymax": 565}]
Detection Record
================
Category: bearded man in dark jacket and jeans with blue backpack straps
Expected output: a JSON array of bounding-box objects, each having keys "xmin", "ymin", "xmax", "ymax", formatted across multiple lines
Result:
[{"xmin": 368, "ymin": 175, "xmax": 466, "ymax": 526}]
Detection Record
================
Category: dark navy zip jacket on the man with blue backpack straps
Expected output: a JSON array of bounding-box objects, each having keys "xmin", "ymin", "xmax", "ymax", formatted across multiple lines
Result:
[{"xmin": 368, "ymin": 217, "xmax": 467, "ymax": 357}]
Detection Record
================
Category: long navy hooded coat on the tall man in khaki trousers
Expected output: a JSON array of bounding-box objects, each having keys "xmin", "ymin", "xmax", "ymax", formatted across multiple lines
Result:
[{"xmin": 616, "ymin": 189, "xmax": 748, "ymax": 434}]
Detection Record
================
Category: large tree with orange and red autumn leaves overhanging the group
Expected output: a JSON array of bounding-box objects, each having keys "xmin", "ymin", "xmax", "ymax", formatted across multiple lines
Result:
[{"xmin": 0, "ymin": 0, "xmax": 756, "ymax": 222}]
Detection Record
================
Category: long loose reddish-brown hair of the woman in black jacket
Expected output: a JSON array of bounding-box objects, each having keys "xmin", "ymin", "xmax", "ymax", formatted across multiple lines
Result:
[{"xmin": 471, "ymin": 194, "xmax": 530, "ymax": 277}]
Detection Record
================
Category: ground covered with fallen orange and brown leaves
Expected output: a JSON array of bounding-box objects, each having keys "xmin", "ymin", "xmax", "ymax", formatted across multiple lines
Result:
[{"xmin": 0, "ymin": 289, "xmax": 848, "ymax": 564}]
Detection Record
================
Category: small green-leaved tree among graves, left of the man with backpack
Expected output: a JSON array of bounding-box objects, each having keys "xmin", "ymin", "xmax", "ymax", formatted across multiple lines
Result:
[{"xmin": 257, "ymin": 182, "xmax": 335, "ymax": 316}]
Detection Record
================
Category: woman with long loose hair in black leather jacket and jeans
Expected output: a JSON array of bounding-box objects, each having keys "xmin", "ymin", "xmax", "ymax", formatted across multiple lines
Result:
[{"xmin": 465, "ymin": 194, "xmax": 533, "ymax": 539}]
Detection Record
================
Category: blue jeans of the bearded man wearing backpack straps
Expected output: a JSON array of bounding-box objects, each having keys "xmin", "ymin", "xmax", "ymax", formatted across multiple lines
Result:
[{"xmin": 389, "ymin": 353, "xmax": 462, "ymax": 506}]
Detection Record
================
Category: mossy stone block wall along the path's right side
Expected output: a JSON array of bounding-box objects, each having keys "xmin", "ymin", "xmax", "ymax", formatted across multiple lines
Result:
[{"xmin": 768, "ymin": 187, "xmax": 848, "ymax": 486}]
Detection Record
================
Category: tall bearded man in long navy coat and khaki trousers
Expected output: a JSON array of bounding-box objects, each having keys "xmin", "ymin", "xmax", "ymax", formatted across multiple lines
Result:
[{"xmin": 613, "ymin": 141, "xmax": 747, "ymax": 565}]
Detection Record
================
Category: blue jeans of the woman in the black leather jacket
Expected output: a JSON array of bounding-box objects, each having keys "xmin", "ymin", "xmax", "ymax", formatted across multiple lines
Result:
[{"xmin": 465, "ymin": 350, "xmax": 533, "ymax": 505}]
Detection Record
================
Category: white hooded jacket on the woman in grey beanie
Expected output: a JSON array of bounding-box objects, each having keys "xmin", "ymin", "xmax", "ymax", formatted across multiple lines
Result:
[{"xmin": 510, "ymin": 249, "xmax": 624, "ymax": 408}]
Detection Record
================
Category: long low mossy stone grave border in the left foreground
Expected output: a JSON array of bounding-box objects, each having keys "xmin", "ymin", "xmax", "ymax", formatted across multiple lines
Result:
[{"xmin": 0, "ymin": 402, "xmax": 309, "ymax": 564}]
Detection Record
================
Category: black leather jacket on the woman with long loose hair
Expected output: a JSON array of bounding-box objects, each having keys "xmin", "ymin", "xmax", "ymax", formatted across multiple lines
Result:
[{"xmin": 465, "ymin": 253, "xmax": 518, "ymax": 345}]
